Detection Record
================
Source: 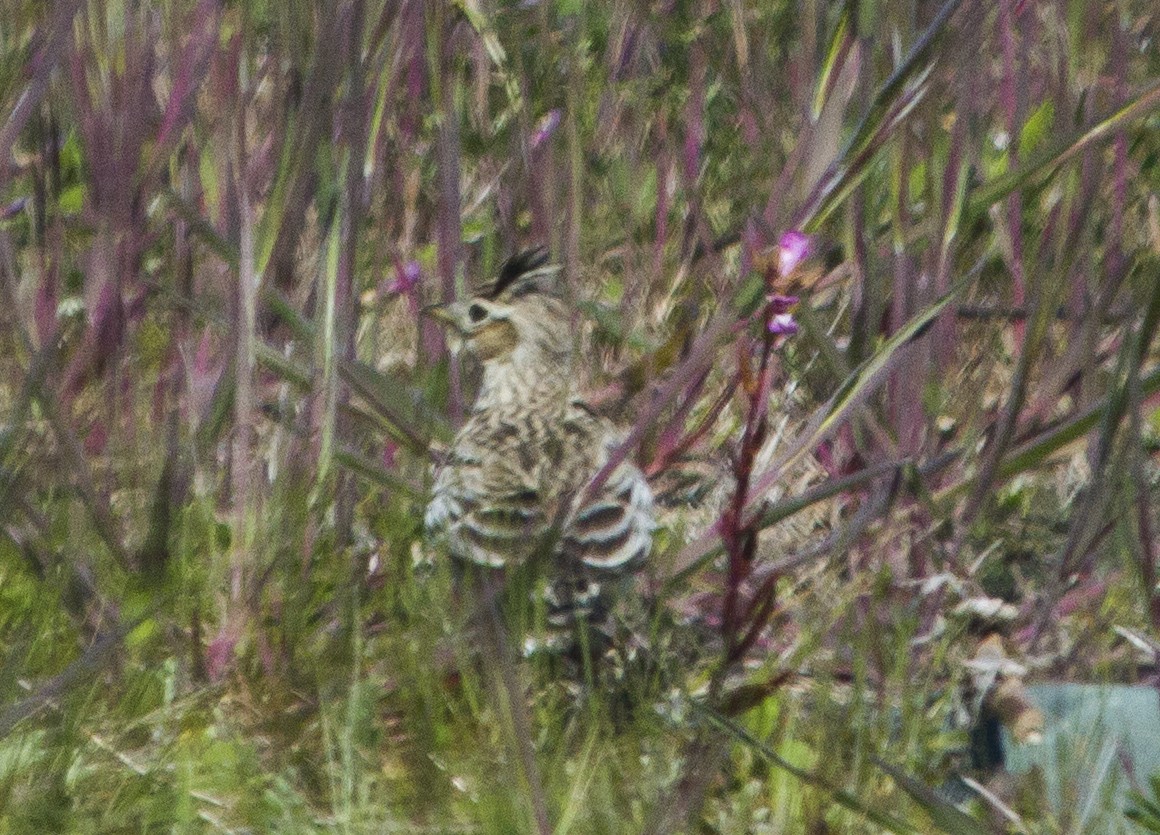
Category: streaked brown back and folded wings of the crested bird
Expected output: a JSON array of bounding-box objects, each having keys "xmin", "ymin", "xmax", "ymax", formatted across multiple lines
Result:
[{"xmin": 427, "ymin": 398, "xmax": 653, "ymax": 574}]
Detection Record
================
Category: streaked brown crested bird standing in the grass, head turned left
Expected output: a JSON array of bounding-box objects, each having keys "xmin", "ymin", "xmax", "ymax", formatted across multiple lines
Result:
[{"xmin": 425, "ymin": 247, "xmax": 655, "ymax": 649}]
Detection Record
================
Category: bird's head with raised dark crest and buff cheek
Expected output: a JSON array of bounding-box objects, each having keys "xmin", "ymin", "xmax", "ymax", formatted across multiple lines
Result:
[{"xmin": 426, "ymin": 247, "xmax": 572, "ymax": 368}]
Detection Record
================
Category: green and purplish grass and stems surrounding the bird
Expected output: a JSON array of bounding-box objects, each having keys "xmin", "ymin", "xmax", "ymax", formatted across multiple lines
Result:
[{"xmin": 0, "ymin": 0, "xmax": 1160, "ymax": 833}]
